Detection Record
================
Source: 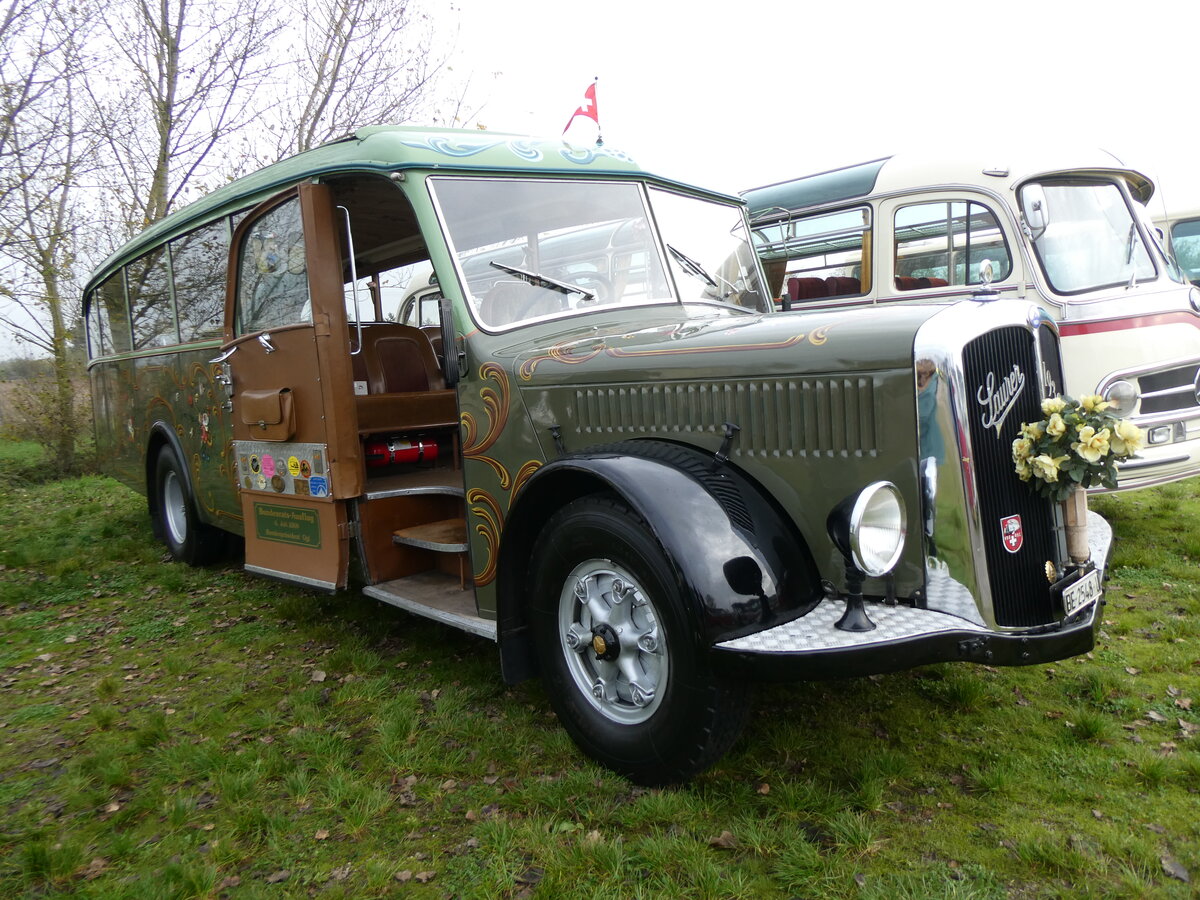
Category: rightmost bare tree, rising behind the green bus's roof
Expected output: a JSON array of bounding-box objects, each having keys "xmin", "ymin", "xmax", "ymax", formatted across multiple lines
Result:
[{"xmin": 275, "ymin": 0, "xmax": 454, "ymax": 156}]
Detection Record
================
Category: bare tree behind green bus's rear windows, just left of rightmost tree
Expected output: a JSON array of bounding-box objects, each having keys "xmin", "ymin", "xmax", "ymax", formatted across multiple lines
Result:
[{"xmin": 89, "ymin": 0, "xmax": 280, "ymax": 230}]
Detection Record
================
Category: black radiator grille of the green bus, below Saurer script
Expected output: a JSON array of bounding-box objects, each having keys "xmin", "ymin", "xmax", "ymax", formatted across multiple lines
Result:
[{"xmin": 962, "ymin": 326, "xmax": 1062, "ymax": 626}]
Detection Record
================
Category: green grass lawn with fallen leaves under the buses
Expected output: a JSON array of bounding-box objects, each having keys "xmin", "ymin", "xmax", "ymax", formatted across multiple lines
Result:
[{"xmin": 0, "ymin": 463, "xmax": 1200, "ymax": 900}]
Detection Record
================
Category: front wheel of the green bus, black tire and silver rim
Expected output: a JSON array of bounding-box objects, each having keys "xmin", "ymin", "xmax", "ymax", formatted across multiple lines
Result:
[{"xmin": 530, "ymin": 494, "xmax": 749, "ymax": 785}]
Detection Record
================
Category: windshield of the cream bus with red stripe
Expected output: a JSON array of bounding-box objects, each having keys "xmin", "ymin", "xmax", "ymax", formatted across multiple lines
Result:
[{"xmin": 1021, "ymin": 181, "xmax": 1154, "ymax": 294}]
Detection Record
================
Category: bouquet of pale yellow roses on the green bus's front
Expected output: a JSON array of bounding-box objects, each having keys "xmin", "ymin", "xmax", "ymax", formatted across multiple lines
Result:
[{"xmin": 1013, "ymin": 394, "xmax": 1146, "ymax": 500}]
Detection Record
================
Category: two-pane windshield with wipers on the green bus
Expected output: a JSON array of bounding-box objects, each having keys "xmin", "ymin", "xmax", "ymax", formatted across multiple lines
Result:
[{"xmin": 430, "ymin": 178, "xmax": 761, "ymax": 329}]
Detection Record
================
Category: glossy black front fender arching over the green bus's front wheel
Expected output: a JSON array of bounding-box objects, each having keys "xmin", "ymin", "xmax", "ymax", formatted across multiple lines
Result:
[{"xmin": 498, "ymin": 442, "xmax": 823, "ymax": 677}]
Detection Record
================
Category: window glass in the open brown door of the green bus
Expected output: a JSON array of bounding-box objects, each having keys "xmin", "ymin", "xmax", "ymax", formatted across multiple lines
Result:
[{"xmin": 236, "ymin": 198, "xmax": 312, "ymax": 335}]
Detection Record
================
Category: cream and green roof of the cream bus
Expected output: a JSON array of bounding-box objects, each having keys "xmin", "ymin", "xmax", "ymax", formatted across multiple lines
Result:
[{"xmin": 742, "ymin": 150, "xmax": 1154, "ymax": 218}]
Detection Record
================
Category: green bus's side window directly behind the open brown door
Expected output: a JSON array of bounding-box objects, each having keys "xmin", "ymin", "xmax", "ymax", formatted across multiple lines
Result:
[{"xmin": 170, "ymin": 220, "xmax": 229, "ymax": 343}]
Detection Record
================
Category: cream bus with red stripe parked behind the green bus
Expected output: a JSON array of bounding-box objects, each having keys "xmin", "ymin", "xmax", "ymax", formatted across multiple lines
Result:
[{"xmin": 743, "ymin": 152, "xmax": 1200, "ymax": 488}]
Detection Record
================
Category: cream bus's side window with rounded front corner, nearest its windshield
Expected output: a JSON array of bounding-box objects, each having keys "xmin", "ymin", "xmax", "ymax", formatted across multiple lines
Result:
[{"xmin": 893, "ymin": 200, "xmax": 1013, "ymax": 290}]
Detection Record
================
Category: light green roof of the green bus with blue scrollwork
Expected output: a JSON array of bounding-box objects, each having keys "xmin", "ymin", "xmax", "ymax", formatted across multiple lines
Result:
[{"xmin": 84, "ymin": 125, "xmax": 739, "ymax": 294}]
